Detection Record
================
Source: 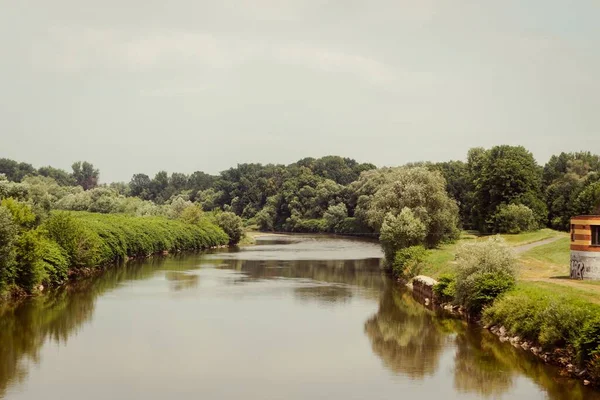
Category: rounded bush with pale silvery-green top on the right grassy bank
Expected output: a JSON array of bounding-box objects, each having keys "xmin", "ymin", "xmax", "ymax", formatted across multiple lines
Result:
[{"xmin": 456, "ymin": 238, "xmax": 516, "ymax": 314}]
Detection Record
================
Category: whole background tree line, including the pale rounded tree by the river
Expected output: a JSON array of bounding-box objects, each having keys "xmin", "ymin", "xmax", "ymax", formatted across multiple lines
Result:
[{"xmin": 0, "ymin": 145, "xmax": 600, "ymax": 290}]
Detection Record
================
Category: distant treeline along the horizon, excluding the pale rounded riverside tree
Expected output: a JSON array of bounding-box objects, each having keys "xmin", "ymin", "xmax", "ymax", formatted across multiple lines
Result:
[{"xmin": 0, "ymin": 146, "xmax": 600, "ymax": 233}]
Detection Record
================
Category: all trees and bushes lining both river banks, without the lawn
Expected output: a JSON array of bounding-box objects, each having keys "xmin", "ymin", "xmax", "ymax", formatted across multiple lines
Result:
[{"xmin": 0, "ymin": 146, "xmax": 600, "ymax": 382}]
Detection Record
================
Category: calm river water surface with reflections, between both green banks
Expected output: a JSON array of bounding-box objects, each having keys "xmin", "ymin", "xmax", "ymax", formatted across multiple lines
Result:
[{"xmin": 0, "ymin": 236, "xmax": 600, "ymax": 400}]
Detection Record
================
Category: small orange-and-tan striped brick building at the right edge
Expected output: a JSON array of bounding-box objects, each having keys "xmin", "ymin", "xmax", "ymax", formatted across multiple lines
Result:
[{"xmin": 571, "ymin": 215, "xmax": 600, "ymax": 280}]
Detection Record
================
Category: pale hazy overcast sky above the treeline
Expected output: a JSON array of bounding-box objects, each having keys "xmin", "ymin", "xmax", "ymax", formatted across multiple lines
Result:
[{"xmin": 0, "ymin": 0, "xmax": 600, "ymax": 182}]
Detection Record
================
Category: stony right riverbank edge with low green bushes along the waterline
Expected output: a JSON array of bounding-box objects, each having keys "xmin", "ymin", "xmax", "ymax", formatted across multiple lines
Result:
[{"xmin": 407, "ymin": 264, "xmax": 600, "ymax": 387}]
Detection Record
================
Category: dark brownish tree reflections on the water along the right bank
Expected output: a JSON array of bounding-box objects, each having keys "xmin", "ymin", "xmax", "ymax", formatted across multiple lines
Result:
[{"xmin": 364, "ymin": 285, "xmax": 600, "ymax": 400}]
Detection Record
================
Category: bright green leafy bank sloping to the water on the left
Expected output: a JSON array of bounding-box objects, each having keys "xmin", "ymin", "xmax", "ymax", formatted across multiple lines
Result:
[{"xmin": 0, "ymin": 211, "xmax": 230, "ymax": 295}]
